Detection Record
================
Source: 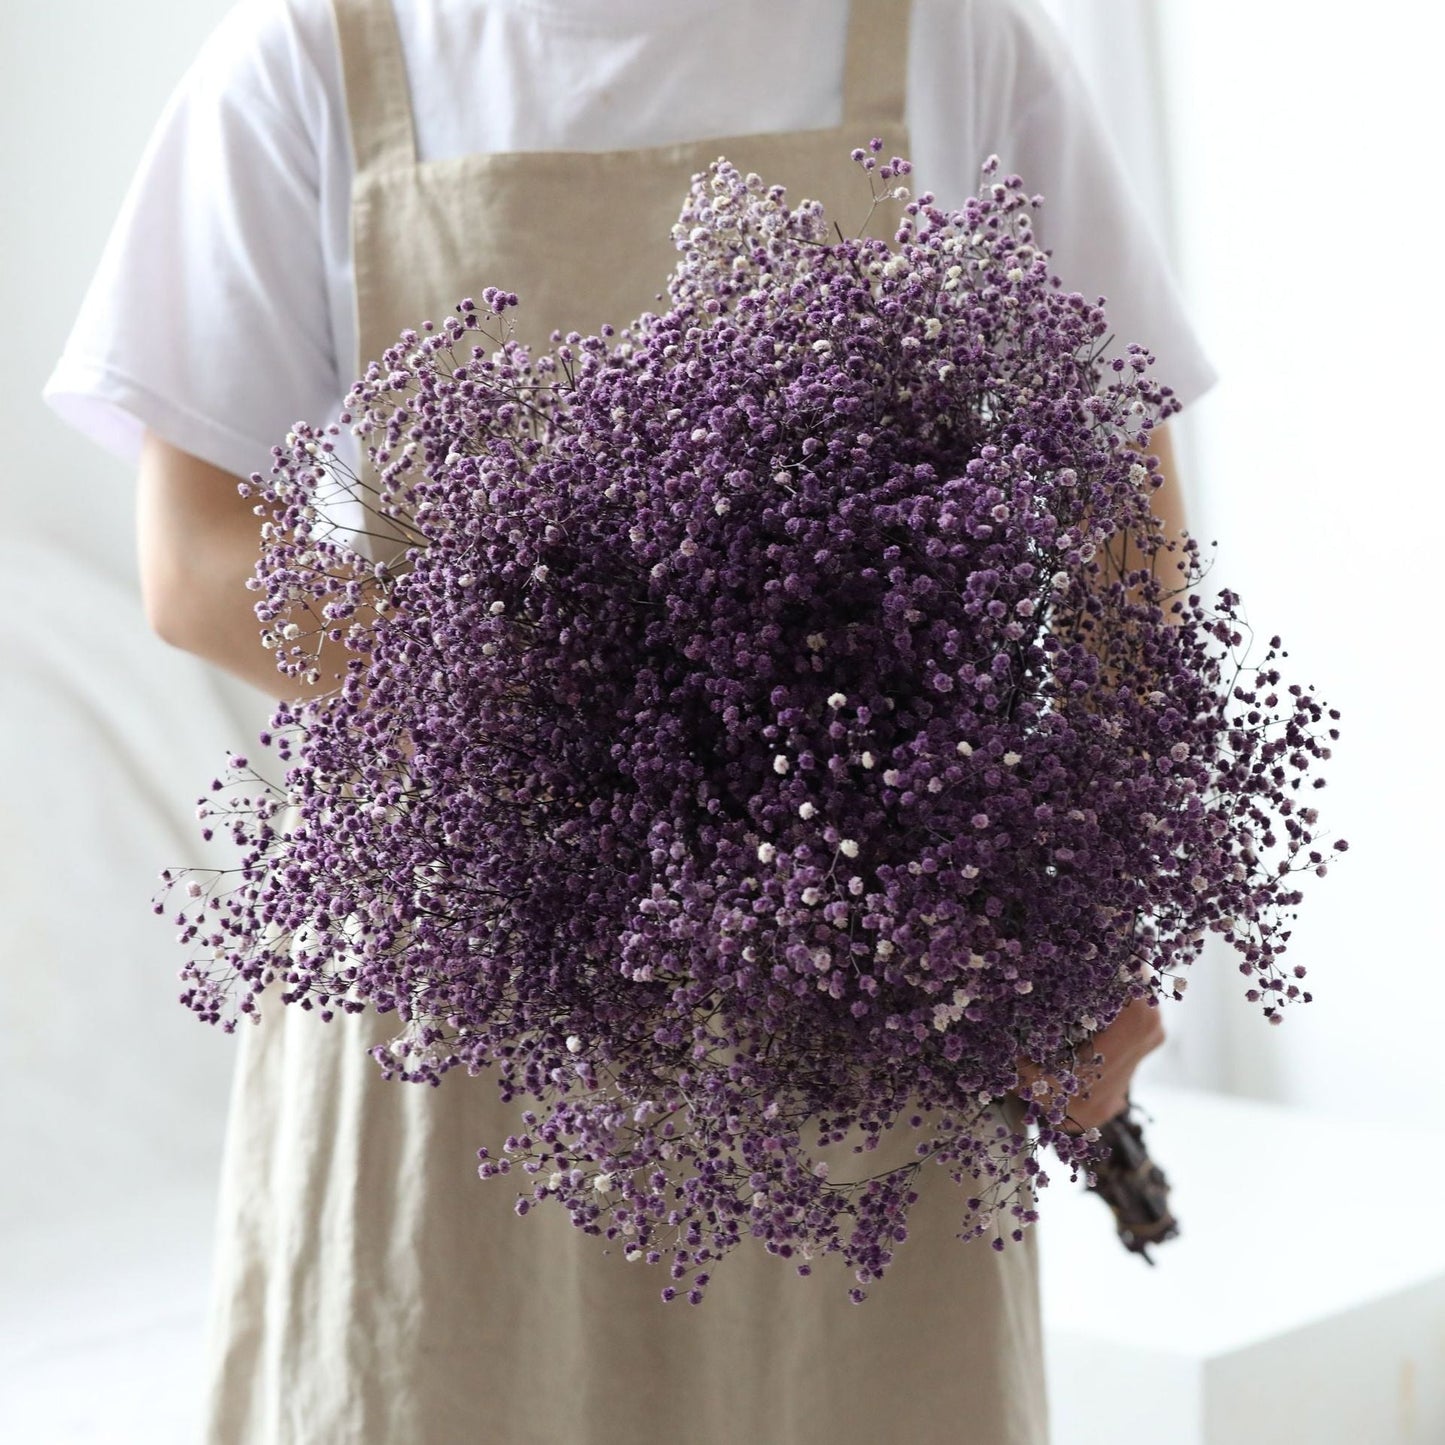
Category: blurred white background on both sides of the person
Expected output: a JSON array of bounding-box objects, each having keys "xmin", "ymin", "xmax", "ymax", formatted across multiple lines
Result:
[{"xmin": 0, "ymin": 0, "xmax": 1445, "ymax": 1442}]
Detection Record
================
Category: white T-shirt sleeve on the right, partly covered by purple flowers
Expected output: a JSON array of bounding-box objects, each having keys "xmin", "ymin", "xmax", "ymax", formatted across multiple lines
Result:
[{"xmin": 910, "ymin": 0, "xmax": 1217, "ymax": 405}]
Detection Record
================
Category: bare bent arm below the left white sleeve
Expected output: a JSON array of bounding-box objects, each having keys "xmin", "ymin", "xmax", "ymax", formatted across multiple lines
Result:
[{"xmin": 136, "ymin": 431, "xmax": 345, "ymax": 699}]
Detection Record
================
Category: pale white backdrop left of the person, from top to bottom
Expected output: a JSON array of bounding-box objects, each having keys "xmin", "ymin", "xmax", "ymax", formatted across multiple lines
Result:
[{"xmin": 0, "ymin": 11, "xmax": 264, "ymax": 1445}]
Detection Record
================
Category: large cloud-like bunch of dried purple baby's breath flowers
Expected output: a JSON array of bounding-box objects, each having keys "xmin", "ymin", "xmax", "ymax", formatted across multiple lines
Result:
[{"xmin": 173, "ymin": 147, "xmax": 1341, "ymax": 1302}]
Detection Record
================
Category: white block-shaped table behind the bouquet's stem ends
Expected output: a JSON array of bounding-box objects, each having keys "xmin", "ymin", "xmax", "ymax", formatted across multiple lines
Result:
[{"xmin": 1039, "ymin": 1084, "xmax": 1445, "ymax": 1445}]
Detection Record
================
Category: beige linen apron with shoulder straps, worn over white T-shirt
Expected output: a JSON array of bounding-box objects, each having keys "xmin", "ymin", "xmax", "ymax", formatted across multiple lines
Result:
[{"xmin": 195, "ymin": 0, "xmax": 1048, "ymax": 1445}]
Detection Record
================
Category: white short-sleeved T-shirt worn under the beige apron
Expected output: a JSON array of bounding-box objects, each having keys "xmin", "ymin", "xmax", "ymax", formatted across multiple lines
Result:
[{"xmin": 45, "ymin": 0, "xmax": 1214, "ymax": 475}]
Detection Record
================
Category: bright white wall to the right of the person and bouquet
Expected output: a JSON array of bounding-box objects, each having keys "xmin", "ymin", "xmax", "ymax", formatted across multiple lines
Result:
[{"xmin": 1159, "ymin": 0, "xmax": 1445, "ymax": 1120}]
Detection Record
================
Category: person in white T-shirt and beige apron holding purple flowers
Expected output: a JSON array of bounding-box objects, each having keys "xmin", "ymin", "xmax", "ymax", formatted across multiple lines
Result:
[{"xmin": 46, "ymin": 0, "xmax": 1211, "ymax": 1445}]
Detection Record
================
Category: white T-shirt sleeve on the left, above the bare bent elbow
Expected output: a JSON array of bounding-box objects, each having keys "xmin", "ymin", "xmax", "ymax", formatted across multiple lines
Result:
[{"xmin": 45, "ymin": 0, "xmax": 341, "ymax": 477}]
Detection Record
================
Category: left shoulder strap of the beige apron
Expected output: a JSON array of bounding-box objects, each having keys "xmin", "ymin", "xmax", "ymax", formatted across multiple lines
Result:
[{"xmin": 331, "ymin": 0, "xmax": 416, "ymax": 176}]
